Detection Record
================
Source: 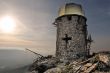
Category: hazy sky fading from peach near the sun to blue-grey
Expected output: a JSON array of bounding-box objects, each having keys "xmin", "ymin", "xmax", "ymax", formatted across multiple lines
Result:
[{"xmin": 0, "ymin": 0, "xmax": 110, "ymax": 54}]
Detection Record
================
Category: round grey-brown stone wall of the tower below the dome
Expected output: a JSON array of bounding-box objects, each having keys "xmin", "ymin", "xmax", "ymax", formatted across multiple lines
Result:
[{"xmin": 55, "ymin": 15, "xmax": 87, "ymax": 59}]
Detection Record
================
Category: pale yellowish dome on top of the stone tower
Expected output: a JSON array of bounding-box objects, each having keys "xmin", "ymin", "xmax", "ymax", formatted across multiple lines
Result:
[{"xmin": 59, "ymin": 3, "xmax": 84, "ymax": 16}]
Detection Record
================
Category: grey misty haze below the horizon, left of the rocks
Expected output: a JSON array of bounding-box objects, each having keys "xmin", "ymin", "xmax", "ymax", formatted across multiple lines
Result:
[{"xmin": 0, "ymin": 48, "xmax": 37, "ymax": 73}]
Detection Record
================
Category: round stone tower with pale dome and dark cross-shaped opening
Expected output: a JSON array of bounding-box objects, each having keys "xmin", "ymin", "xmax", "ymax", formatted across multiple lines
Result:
[{"xmin": 54, "ymin": 3, "xmax": 88, "ymax": 60}]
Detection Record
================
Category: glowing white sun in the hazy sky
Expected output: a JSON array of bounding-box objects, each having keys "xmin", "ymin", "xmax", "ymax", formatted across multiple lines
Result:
[{"xmin": 0, "ymin": 16, "xmax": 16, "ymax": 33}]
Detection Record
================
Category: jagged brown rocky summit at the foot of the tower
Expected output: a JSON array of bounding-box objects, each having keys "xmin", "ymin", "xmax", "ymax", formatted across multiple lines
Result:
[{"xmin": 29, "ymin": 52, "xmax": 110, "ymax": 73}]
